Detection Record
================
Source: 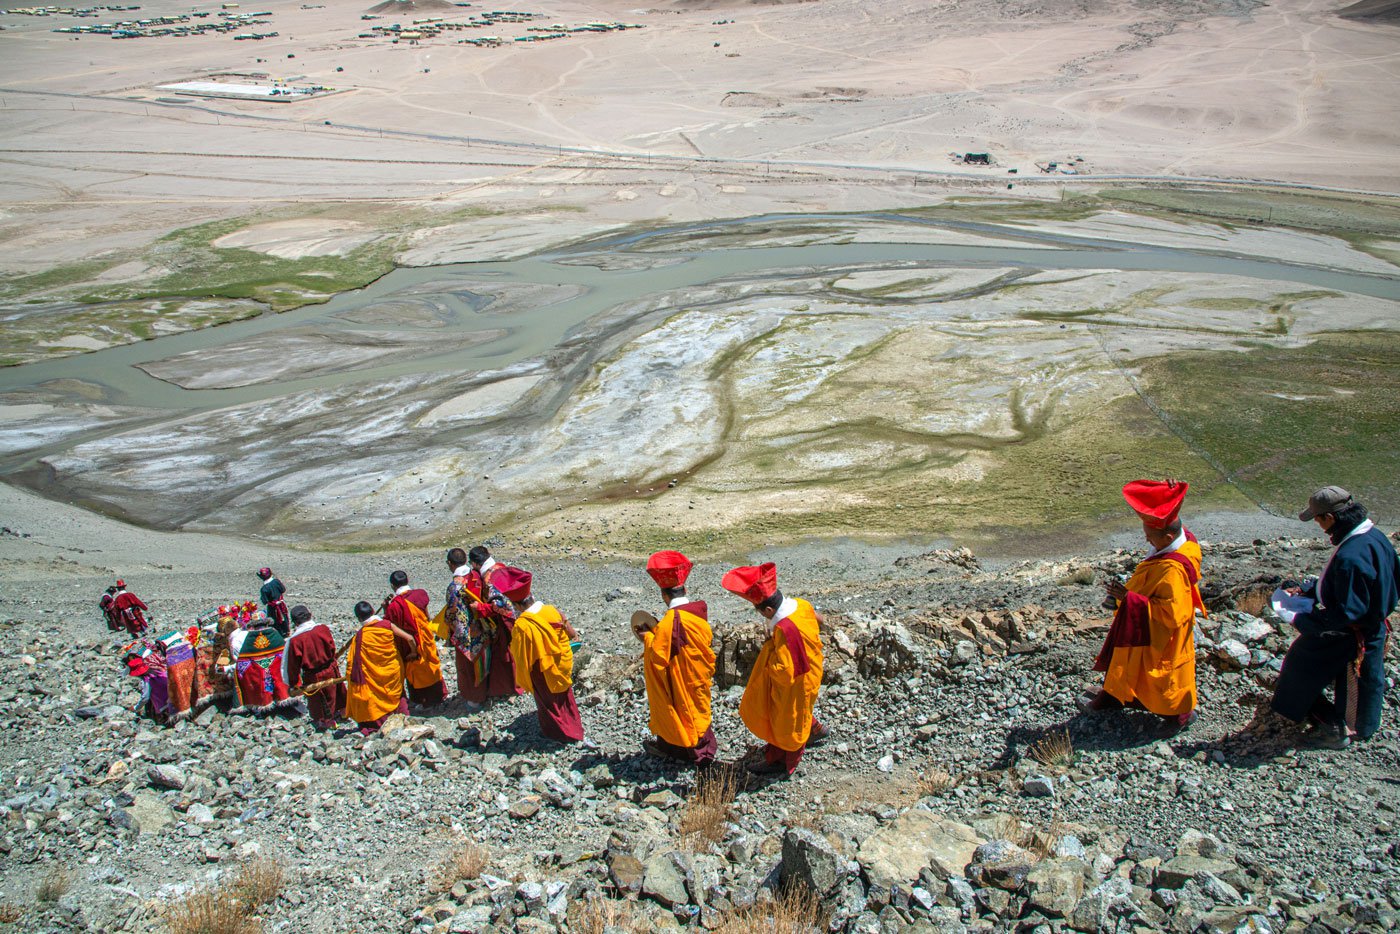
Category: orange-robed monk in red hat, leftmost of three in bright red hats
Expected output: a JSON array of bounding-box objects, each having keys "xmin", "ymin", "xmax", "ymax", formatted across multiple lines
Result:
[{"xmin": 633, "ymin": 552, "xmax": 718, "ymax": 766}]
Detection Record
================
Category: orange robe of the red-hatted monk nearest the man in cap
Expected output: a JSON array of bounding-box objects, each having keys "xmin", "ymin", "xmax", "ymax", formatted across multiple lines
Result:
[{"xmin": 1103, "ymin": 541, "xmax": 1205, "ymax": 717}]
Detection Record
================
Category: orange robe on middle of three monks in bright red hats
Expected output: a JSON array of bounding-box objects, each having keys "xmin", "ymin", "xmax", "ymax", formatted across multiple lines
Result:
[{"xmin": 739, "ymin": 599, "xmax": 822, "ymax": 752}]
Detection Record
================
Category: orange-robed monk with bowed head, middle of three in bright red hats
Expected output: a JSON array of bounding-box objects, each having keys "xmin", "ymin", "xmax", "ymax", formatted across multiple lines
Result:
[{"xmin": 720, "ymin": 562, "xmax": 826, "ymax": 776}]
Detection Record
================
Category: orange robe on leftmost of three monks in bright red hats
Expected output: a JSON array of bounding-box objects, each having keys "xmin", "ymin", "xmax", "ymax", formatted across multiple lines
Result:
[{"xmin": 641, "ymin": 608, "xmax": 714, "ymax": 749}]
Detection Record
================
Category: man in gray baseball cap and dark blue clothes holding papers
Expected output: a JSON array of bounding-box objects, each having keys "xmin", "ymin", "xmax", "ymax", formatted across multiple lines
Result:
[{"xmin": 1273, "ymin": 486, "xmax": 1400, "ymax": 748}]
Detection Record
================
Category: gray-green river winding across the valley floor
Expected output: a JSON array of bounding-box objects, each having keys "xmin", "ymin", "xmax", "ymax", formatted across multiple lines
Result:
[{"xmin": 0, "ymin": 216, "xmax": 1400, "ymax": 412}]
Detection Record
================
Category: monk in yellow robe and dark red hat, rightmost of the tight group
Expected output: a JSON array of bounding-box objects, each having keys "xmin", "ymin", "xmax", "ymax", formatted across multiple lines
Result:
[{"xmin": 494, "ymin": 567, "xmax": 584, "ymax": 742}]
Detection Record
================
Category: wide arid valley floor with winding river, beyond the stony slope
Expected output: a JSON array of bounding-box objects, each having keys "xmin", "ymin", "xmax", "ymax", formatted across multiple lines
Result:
[{"xmin": 0, "ymin": 0, "xmax": 1400, "ymax": 552}]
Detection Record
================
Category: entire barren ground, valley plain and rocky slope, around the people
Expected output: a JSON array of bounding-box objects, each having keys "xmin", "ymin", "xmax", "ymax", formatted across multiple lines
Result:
[{"xmin": 0, "ymin": 0, "xmax": 1400, "ymax": 934}]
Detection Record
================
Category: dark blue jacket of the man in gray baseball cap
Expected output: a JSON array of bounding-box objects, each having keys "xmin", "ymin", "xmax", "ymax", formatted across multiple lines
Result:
[{"xmin": 1294, "ymin": 528, "xmax": 1400, "ymax": 636}]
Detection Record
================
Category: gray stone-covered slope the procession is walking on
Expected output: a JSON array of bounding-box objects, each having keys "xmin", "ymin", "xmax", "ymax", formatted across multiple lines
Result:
[{"xmin": 0, "ymin": 541, "xmax": 1400, "ymax": 934}]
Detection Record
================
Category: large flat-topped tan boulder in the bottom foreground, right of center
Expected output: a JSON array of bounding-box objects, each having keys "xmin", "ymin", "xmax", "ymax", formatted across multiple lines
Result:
[{"xmin": 857, "ymin": 811, "xmax": 987, "ymax": 886}]
